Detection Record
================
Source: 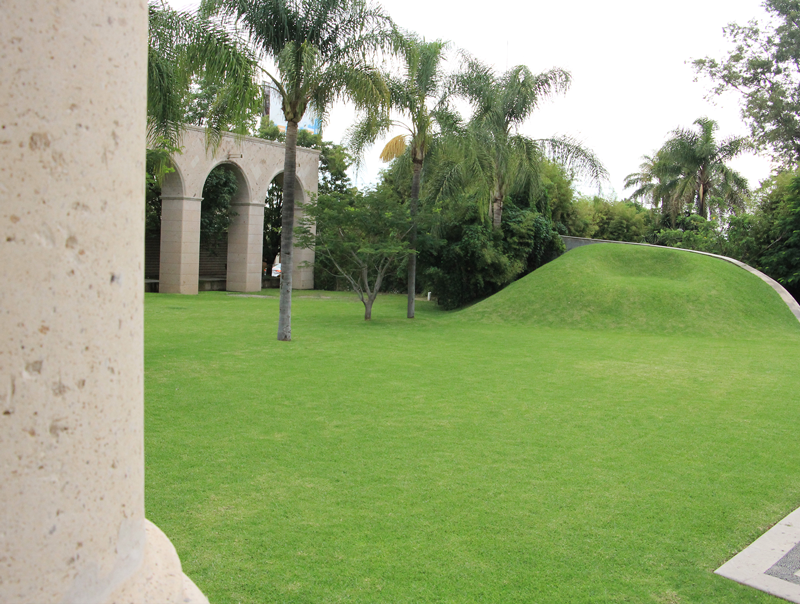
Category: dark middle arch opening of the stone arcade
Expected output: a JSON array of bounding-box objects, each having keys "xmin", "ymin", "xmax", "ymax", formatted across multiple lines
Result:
[{"xmin": 198, "ymin": 164, "xmax": 239, "ymax": 291}]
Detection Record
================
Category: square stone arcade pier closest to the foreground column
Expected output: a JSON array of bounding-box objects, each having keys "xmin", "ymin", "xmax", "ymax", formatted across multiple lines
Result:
[{"xmin": 158, "ymin": 196, "xmax": 203, "ymax": 294}]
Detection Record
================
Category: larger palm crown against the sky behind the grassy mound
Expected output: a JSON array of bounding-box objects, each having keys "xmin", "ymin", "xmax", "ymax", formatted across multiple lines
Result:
[{"xmin": 661, "ymin": 117, "xmax": 751, "ymax": 218}]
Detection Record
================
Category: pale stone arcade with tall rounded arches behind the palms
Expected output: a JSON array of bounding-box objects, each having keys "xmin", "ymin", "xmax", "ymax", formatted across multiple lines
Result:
[{"xmin": 159, "ymin": 127, "xmax": 319, "ymax": 294}]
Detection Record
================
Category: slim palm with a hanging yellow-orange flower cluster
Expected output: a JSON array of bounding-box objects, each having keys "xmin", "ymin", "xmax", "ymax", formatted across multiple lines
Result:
[{"xmin": 349, "ymin": 33, "xmax": 454, "ymax": 319}]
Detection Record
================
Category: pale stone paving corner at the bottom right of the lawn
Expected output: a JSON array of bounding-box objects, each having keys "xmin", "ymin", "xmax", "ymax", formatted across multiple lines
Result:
[{"xmin": 714, "ymin": 508, "xmax": 800, "ymax": 604}]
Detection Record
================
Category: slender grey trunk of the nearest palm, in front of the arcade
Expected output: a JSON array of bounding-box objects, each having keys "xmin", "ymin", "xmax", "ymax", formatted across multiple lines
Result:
[{"xmin": 278, "ymin": 122, "xmax": 297, "ymax": 342}]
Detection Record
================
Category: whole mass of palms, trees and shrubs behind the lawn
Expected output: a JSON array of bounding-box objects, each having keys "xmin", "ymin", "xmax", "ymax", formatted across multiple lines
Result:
[{"xmin": 147, "ymin": 0, "xmax": 800, "ymax": 328}]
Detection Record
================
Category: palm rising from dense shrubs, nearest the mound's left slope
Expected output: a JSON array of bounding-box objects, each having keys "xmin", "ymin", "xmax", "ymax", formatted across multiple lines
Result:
[{"xmin": 454, "ymin": 57, "xmax": 607, "ymax": 228}]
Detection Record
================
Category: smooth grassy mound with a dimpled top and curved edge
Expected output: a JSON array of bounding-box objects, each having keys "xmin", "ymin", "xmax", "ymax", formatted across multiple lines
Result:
[{"xmin": 459, "ymin": 243, "xmax": 800, "ymax": 337}]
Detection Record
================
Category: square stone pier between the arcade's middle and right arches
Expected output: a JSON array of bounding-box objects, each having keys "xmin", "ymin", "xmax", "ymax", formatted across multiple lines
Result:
[{"xmin": 225, "ymin": 202, "xmax": 264, "ymax": 292}]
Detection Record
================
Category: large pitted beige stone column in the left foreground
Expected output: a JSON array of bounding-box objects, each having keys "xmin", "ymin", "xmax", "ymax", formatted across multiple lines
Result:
[{"xmin": 0, "ymin": 0, "xmax": 204, "ymax": 604}]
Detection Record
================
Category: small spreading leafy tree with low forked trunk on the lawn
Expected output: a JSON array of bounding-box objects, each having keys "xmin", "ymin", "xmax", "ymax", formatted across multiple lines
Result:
[{"xmin": 297, "ymin": 191, "xmax": 411, "ymax": 321}]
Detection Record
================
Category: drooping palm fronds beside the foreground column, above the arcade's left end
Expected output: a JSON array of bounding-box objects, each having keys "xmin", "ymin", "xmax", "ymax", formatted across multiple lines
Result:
[{"xmin": 147, "ymin": 3, "xmax": 261, "ymax": 157}]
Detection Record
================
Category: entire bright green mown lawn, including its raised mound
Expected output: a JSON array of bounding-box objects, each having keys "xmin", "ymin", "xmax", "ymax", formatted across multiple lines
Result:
[{"xmin": 145, "ymin": 245, "xmax": 800, "ymax": 604}]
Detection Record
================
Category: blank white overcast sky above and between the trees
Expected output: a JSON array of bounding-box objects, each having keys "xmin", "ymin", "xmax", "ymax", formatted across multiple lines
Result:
[{"xmin": 169, "ymin": 0, "xmax": 770, "ymax": 198}]
